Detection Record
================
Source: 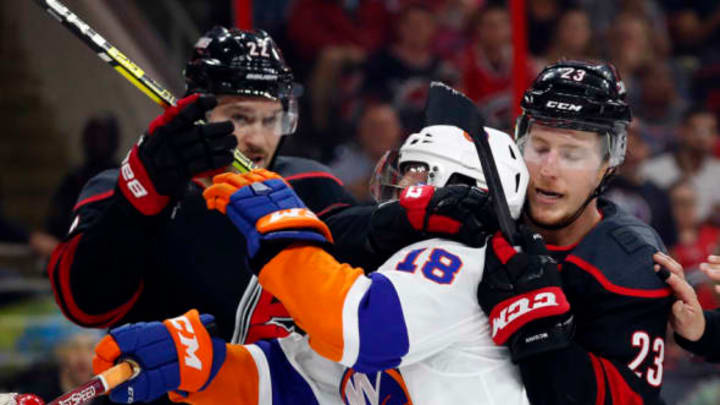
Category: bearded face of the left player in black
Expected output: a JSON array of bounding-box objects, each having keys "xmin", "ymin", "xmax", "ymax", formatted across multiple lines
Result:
[{"xmin": 208, "ymin": 96, "xmax": 283, "ymax": 168}]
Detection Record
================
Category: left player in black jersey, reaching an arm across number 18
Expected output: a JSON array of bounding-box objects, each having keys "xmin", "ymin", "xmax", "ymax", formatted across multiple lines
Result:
[{"xmin": 48, "ymin": 27, "xmax": 490, "ymax": 343}]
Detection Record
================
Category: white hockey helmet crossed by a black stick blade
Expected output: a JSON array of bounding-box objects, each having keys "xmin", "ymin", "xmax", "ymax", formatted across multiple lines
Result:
[{"xmin": 371, "ymin": 125, "xmax": 530, "ymax": 219}]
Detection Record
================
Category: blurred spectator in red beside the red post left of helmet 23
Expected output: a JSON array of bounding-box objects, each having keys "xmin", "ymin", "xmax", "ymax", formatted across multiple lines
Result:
[{"xmin": 456, "ymin": 4, "xmax": 534, "ymax": 129}]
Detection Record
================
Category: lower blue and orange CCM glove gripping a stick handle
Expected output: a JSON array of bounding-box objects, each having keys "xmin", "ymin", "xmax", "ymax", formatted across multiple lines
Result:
[{"xmin": 93, "ymin": 309, "xmax": 226, "ymax": 404}]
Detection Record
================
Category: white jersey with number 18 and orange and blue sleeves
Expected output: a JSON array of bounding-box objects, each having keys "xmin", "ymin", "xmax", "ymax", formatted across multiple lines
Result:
[{"xmin": 184, "ymin": 239, "xmax": 528, "ymax": 405}]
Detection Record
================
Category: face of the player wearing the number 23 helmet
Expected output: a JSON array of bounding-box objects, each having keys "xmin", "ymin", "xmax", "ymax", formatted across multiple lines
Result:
[{"xmin": 523, "ymin": 124, "xmax": 607, "ymax": 225}]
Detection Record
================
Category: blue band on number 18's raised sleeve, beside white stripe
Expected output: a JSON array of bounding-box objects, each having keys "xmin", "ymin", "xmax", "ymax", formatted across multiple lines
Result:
[{"xmin": 353, "ymin": 273, "xmax": 409, "ymax": 373}]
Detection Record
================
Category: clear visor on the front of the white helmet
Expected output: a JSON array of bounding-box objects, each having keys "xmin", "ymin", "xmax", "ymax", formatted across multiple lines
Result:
[{"xmin": 370, "ymin": 150, "xmax": 429, "ymax": 203}]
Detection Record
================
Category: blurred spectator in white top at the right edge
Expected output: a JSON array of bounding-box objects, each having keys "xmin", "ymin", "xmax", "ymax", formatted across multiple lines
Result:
[{"xmin": 641, "ymin": 107, "xmax": 720, "ymax": 222}]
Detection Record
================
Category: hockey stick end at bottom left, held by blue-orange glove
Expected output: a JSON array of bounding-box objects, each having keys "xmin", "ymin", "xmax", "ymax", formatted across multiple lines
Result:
[{"xmin": 47, "ymin": 360, "xmax": 140, "ymax": 405}]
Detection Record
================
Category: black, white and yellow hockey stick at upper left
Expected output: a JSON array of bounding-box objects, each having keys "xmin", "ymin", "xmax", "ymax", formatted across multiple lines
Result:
[{"xmin": 35, "ymin": 0, "xmax": 255, "ymax": 173}]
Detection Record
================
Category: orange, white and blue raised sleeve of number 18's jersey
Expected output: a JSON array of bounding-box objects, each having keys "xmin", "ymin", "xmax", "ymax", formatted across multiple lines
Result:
[{"xmin": 259, "ymin": 244, "xmax": 408, "ymax": 372}]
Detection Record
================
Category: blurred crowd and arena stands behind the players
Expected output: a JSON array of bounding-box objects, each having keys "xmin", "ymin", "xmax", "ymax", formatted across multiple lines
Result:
[{"xmin": 0, "ymin": 0, "xmax": 720, "ymax": 404}]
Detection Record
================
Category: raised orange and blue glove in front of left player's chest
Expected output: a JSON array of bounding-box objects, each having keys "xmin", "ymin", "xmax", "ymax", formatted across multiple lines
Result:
[{"xmin": 203, "ymin": 169, "xmax": 333, "ymax": 274}]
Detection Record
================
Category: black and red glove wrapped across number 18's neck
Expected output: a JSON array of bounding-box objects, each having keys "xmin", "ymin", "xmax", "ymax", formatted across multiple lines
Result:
[{"xmin": 369, "ymin": 184, "xmax": 498, "ymax": 252}]
